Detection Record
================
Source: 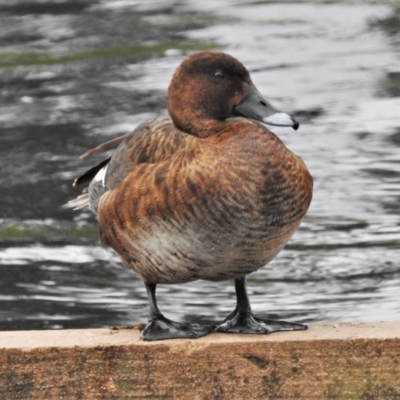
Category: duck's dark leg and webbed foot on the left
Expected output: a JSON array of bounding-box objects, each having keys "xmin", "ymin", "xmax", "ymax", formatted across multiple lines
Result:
[{"xmin": 141, "ymin": 283, "xmax": 215, "ymax": 341}]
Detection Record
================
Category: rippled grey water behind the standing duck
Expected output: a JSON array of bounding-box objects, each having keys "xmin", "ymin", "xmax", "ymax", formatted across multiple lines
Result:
[{"xmin": 0, "ymin": 0, "xmax": 400, "ymax": 330}]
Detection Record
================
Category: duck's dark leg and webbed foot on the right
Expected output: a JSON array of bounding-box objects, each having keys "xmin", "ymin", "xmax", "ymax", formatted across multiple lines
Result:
[{"xmin": 217, "ymin": 278, "xmax": 307, "ymax": 334}]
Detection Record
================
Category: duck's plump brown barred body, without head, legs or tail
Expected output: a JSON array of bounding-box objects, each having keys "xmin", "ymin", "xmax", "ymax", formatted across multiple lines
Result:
[{"xmin": 94, "ymin": 118, "xmax": 312, "ymax": 283}]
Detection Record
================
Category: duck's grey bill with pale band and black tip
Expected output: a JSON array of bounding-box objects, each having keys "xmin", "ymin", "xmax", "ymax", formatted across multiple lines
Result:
[{"xmin": 234, "ymin": 83, "xmax": 299, "ymax": 130}]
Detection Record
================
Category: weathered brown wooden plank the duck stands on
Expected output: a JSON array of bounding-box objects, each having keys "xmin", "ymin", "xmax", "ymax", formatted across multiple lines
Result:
[{"xmin": 0, "ymin": 322, "xmax": 400, "ymax": 399}]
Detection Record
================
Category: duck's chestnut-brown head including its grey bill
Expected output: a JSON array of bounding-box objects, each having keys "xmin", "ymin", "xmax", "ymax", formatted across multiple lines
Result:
[{"xmin": 167, "ymin": 52, "xmax": 299, "ymax": 137}]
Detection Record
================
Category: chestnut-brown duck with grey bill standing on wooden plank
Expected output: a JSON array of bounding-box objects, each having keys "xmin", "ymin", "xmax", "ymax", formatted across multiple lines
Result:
[{"xmin": 73, "ymin": 51, "xmax": 313, "ymax": 341}]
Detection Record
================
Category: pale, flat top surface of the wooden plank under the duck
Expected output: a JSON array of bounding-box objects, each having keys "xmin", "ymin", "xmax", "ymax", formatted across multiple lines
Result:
[{"xmin": 0, "ymin": 321, "xmax": 400, "ymax": 351}]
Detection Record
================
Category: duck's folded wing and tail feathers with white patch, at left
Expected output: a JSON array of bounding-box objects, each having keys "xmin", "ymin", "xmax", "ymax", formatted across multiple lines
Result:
[{"xmin": 71, "ymin": 117, "xmax": 188, "ymax": 213}]
